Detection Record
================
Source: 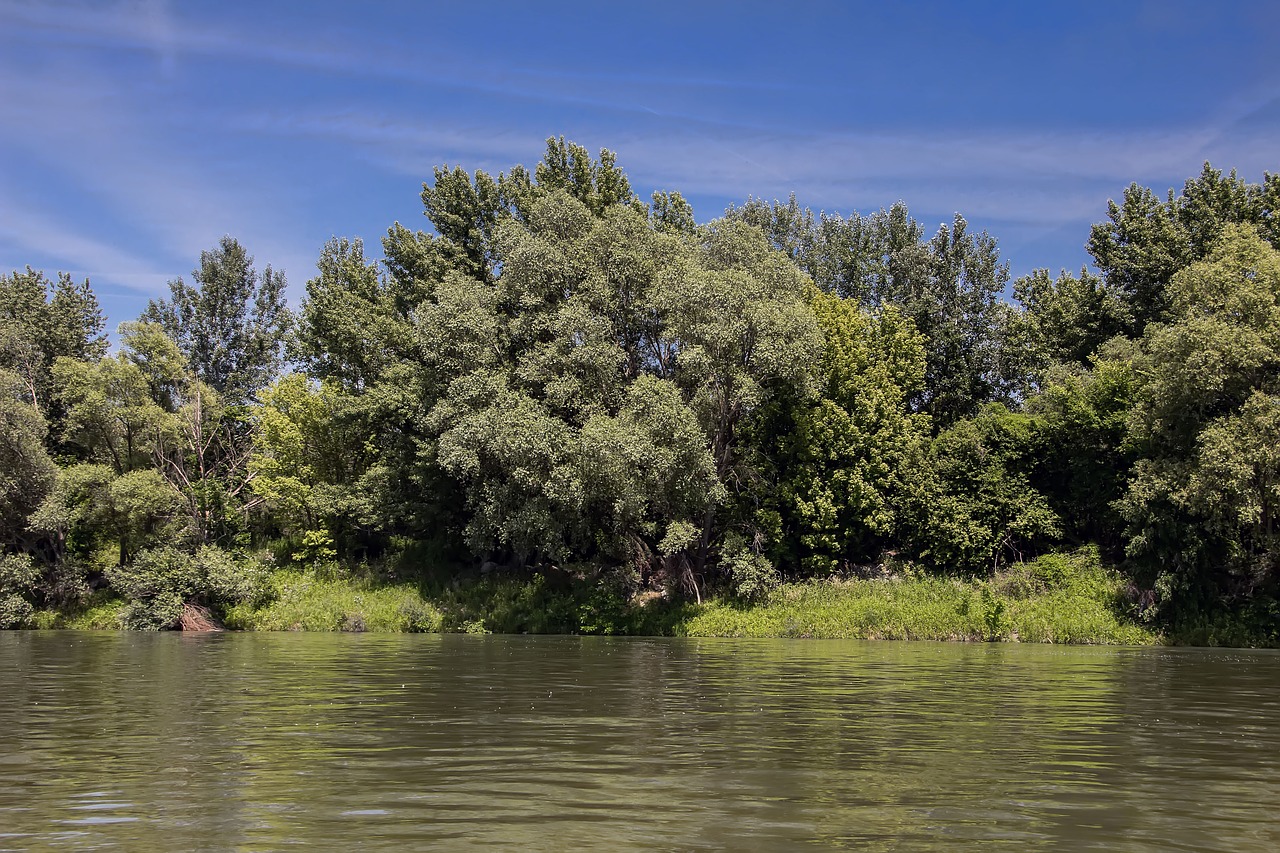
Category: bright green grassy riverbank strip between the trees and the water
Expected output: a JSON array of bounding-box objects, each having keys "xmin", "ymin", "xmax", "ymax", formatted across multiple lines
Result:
[{"xmin": 41, "ymin": 549, "xmax": 1218, "ymax": 646}]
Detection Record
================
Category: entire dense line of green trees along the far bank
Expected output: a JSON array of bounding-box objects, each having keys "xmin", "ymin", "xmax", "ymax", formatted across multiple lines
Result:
[{"xmin": 0, "ymin": 140, "xmax": 1280, "ymax": 631}]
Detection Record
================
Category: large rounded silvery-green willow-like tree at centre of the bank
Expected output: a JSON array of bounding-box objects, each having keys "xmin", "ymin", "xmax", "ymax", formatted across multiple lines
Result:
[{"xmin": 416, "ymin": 191, "xmax": 819, "ymax": 591}]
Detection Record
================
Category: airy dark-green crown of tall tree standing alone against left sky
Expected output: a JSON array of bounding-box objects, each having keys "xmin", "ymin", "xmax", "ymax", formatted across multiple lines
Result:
[{"xmin": 142, "ymin": 237, "xmax": 292, "ymax": 406}]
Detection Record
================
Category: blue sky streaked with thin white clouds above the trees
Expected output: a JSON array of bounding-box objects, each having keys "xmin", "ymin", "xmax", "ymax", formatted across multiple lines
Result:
[{"xmin": 0, "ymin": 0, "xmax": 1280, "ymax": 328}]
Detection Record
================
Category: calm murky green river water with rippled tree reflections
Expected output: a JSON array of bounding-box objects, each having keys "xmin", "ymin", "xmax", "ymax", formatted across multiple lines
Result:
[{"xmin": 0, "ymin": 631, "xmax": 1280, "ymax": 853}]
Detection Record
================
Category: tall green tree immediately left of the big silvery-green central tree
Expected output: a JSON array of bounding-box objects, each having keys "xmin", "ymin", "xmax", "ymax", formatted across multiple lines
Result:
[{"xmin": 294, "ymin": 235, "xmax": 460, "ymax": 548}]
